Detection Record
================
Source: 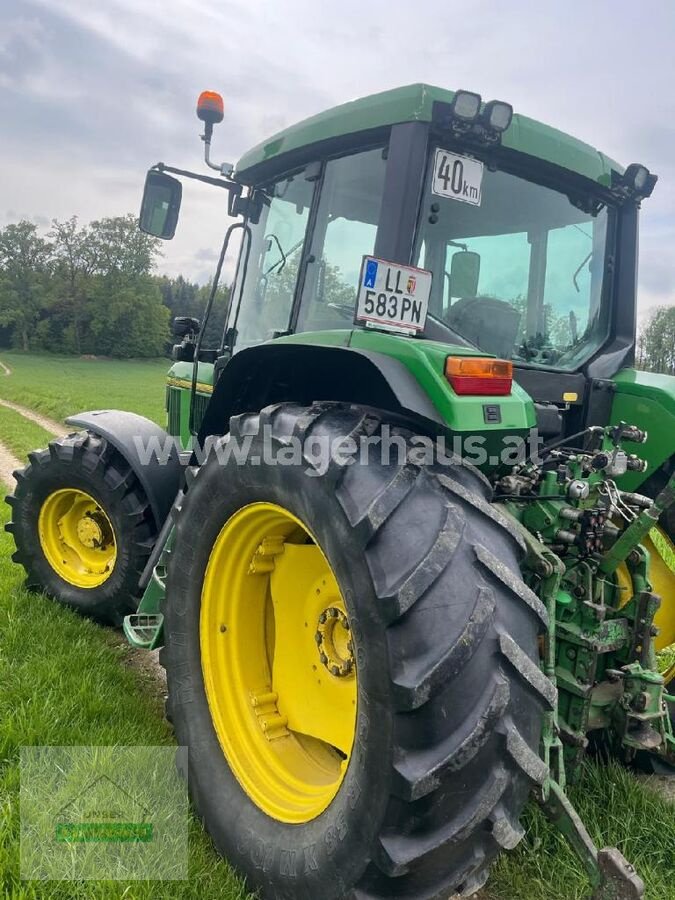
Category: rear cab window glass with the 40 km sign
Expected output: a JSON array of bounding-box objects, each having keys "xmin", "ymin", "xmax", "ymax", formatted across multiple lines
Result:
[{"xmin": 417, "ymin": 148, "xmax": 607, "ymax": 369}]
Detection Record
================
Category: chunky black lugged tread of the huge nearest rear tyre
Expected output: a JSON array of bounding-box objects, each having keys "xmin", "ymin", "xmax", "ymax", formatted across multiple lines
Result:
[{"xmin": 160, "ymin": 402, "xmax": 556, "ymax": 900}]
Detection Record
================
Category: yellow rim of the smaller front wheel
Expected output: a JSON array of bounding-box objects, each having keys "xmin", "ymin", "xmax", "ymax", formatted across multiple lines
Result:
[{"xmin": 38, "ymin": 488, "xmax": 117, "ymax": 588}]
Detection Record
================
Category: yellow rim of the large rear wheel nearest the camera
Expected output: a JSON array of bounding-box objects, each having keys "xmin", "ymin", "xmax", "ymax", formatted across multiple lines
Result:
[{"xmin": 200, "ymin": 503, "xmax": 357, "ymax": 824}]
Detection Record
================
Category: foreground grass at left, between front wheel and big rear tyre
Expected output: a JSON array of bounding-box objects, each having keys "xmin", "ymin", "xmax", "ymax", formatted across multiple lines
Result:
[{"xmin": 0, "ymin": 506, "xmax": 248, "ymax": 900}]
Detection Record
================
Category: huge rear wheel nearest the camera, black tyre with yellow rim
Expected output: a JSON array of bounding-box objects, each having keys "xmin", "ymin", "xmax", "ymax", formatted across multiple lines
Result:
[{"xmin": 160, "ymin": 403, "xmax": 555, "ymax": 900}]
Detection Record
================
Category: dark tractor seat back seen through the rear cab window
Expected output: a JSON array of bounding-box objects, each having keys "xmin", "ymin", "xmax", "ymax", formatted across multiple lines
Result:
[{"xmin": 446, "ymin": 297, "xmax": 520, "ymax": 359}]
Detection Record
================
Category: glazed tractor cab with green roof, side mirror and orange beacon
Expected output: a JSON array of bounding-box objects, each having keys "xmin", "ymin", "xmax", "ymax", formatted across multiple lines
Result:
[{"xmin": 141, "ymin": 85, "xmax": 656, "ymax": 458}]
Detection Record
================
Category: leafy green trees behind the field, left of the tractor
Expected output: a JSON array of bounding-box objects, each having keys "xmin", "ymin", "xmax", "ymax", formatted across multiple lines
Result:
[{"xmin": 0, "ymin": 215, "xmax": 227, "ymax": 358}]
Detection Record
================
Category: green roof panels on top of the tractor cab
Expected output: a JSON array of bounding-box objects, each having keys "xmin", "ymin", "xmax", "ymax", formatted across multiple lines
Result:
[{"xmin": 235, "ymin": 84, "xmax": 623, "ymax": 187}]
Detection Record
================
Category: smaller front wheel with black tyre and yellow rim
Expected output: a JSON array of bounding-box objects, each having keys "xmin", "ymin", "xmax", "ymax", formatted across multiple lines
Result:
[{"xmin": 5, "ymin": 431, "xmax": 156, "ymax": 625}]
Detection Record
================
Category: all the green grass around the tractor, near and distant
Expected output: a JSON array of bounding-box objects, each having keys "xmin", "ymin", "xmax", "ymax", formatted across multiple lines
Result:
[{"xmin": 0, "ymin": 354, "xmax": 675, "ymax": 900}]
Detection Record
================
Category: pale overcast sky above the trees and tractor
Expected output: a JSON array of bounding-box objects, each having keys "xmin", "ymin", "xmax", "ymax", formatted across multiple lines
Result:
[{"xmin": 0, "ymin": 0, "xmax": 675, "ymax": 311}]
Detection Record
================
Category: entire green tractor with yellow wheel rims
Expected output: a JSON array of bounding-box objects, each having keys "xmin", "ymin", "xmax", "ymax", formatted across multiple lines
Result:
[{"xmin": 9, "ymin": 84, "xmax": 675, "ymax": 900}]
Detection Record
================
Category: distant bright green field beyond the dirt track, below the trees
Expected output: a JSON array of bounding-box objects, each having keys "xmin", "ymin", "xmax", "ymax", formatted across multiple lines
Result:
[{"xmin": 0, "ymin": 351, "xmax": 171, "ymax": 425}]
